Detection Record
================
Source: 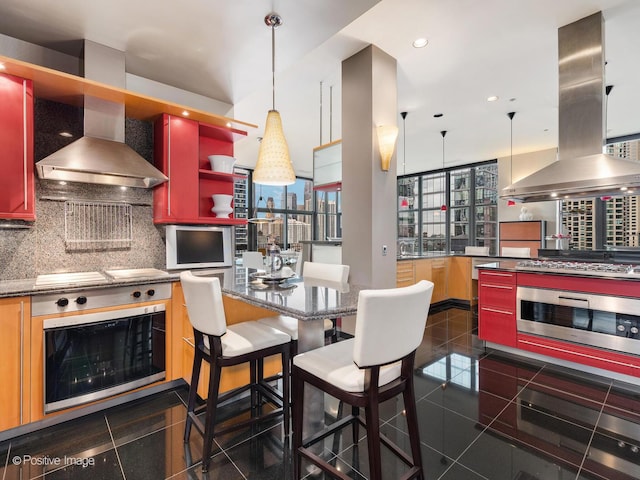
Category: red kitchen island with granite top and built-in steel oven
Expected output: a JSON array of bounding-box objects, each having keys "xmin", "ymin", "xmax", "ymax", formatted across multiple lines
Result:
[{"xmin": 478, "ymin": 260, "xmax": 640, "ymax": 383}]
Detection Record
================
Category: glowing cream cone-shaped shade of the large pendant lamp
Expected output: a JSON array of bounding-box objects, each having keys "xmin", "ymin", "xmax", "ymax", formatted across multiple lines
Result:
[{"xmin": 253, "ymin": 110, "xmax": 296, "ymax": 185}]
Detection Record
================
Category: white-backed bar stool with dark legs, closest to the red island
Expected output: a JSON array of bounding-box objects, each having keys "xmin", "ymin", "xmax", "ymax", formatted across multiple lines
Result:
[{"xmin": 292, "ymin": 280, "xmax": 433, "ymax": 480}]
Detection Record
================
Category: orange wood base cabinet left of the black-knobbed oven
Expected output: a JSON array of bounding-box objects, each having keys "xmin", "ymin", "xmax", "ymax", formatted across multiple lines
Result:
[{"xmin": 0, "ymin": 297, "xmax": 31, "ymax": 431}]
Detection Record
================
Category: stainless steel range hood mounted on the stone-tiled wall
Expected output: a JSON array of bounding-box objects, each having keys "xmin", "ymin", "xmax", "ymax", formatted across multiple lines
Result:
[{"xmin": 36, "ymin": 41, "xmax": 168, "ymax": 188}]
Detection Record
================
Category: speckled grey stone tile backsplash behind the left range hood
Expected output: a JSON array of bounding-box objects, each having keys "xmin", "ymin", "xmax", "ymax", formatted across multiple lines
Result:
[{"xmin": 0, "ymin": 99, "xmax": 165, "ymax": 280}]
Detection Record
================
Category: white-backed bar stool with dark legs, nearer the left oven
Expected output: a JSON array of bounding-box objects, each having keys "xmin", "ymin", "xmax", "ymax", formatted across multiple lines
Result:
[{"xmin": 180, "ymin": 272, "xmax": 291, "ymax": 472}]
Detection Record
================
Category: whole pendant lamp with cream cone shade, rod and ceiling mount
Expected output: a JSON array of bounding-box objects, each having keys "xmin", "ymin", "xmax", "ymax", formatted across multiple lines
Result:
[{"xmin": 252, "ymin": 13, "xmax": 296, "ymax": 185}]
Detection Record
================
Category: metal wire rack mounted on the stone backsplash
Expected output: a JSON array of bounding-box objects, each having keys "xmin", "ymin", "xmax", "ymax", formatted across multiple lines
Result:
[{"xmin": 64, "ymin": 201, "xmax": 133, "ymax": 251}]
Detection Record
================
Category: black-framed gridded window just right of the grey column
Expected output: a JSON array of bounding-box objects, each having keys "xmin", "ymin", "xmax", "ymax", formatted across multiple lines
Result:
[{"xmin": 398, "ymin": 161, "xmax": 498, "ymax": 256}]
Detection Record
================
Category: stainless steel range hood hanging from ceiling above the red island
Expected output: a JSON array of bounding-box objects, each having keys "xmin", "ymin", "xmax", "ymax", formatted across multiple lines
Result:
[{"xmin": 500, "ymin": 12, "xmax": 640, "ymax": 202}]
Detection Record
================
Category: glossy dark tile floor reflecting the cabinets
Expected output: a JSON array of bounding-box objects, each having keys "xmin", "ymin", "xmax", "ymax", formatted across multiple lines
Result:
[{"xmin": 0, "ymin": 309, "xmax": 640, "ymax": 480}]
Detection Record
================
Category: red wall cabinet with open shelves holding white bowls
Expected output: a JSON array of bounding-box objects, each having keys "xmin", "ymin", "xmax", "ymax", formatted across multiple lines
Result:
[{"xmin": 153, "ymin": 114, "xmax": 246, "ymax": 225}]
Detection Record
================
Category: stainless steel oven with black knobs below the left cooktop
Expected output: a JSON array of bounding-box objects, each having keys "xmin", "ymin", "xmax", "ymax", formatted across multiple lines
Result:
[{"xmin": 34, "ymin": 284, "xmax": 170, "ymax": 413}]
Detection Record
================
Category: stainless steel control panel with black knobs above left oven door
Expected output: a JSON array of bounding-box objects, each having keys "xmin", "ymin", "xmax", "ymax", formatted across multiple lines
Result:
[{"xmin": 31, "ymin": 283, "xmax": 171, "ymax": 316}]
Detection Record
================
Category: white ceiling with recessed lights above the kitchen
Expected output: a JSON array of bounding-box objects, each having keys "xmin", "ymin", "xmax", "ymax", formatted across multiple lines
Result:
[{"xmin": 0, "ymin": 0, "xmax": 640, "ymax": 176}]
